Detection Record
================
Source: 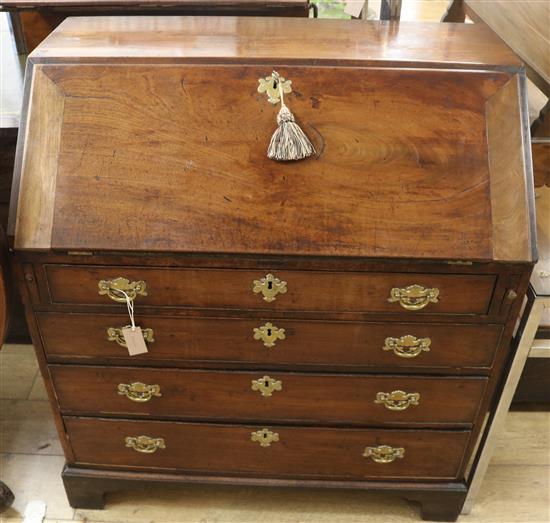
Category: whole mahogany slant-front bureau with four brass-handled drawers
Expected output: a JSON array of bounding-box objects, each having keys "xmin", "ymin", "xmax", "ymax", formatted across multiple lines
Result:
[{"xmin": 10, "ymin": 18, "xmax": 536, "ymax": 521}]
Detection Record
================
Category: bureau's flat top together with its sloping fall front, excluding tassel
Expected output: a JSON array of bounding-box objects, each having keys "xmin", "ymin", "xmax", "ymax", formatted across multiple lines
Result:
[{"xmin": 10, "ymin": 18, "xmax": 534, "ymax": 261}]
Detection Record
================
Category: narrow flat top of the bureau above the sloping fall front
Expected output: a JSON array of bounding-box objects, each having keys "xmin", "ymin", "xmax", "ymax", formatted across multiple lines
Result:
[{"xmin": 31, "ymin": 17, "xmax": 520, "ymax": 67}]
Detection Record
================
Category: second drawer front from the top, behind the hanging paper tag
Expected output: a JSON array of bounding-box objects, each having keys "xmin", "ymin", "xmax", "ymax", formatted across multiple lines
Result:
[{"xmin": 36, "ymin": 313, "xmax": 501, "ymax": 372}]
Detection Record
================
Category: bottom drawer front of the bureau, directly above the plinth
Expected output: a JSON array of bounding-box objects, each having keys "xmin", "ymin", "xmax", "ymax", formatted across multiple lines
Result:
[{"xmin": 64, "ymin": 417, "xmax": 470, "ymax": 481}]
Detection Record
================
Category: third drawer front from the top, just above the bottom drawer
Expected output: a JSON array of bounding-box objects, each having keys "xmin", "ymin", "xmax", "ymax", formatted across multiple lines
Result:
[{"xmin": 50, "ymin": 365, "xmax": 487, "ymax": 426}]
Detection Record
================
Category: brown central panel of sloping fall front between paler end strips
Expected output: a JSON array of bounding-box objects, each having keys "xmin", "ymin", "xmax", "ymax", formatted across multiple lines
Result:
[{"xmin": 16, "ymin": 66, "xmax": 512, "ymax": 260}]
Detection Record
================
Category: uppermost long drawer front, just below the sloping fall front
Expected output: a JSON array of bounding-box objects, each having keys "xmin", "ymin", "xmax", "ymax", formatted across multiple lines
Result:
[{"xmin": 46, "ymin": 265, "xmax": 496, "ymax": 315}]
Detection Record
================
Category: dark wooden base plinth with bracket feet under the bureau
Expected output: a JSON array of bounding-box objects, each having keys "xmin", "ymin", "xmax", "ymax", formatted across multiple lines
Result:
[{"xmin": 61, "ymin": 465, "xmax": 467, "ymax": 521}]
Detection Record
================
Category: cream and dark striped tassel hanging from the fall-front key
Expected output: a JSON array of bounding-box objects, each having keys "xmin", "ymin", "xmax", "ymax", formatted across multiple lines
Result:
[{"xmin": 267, "ymin": 83, "xmax": 316, "ymax": 162}]
